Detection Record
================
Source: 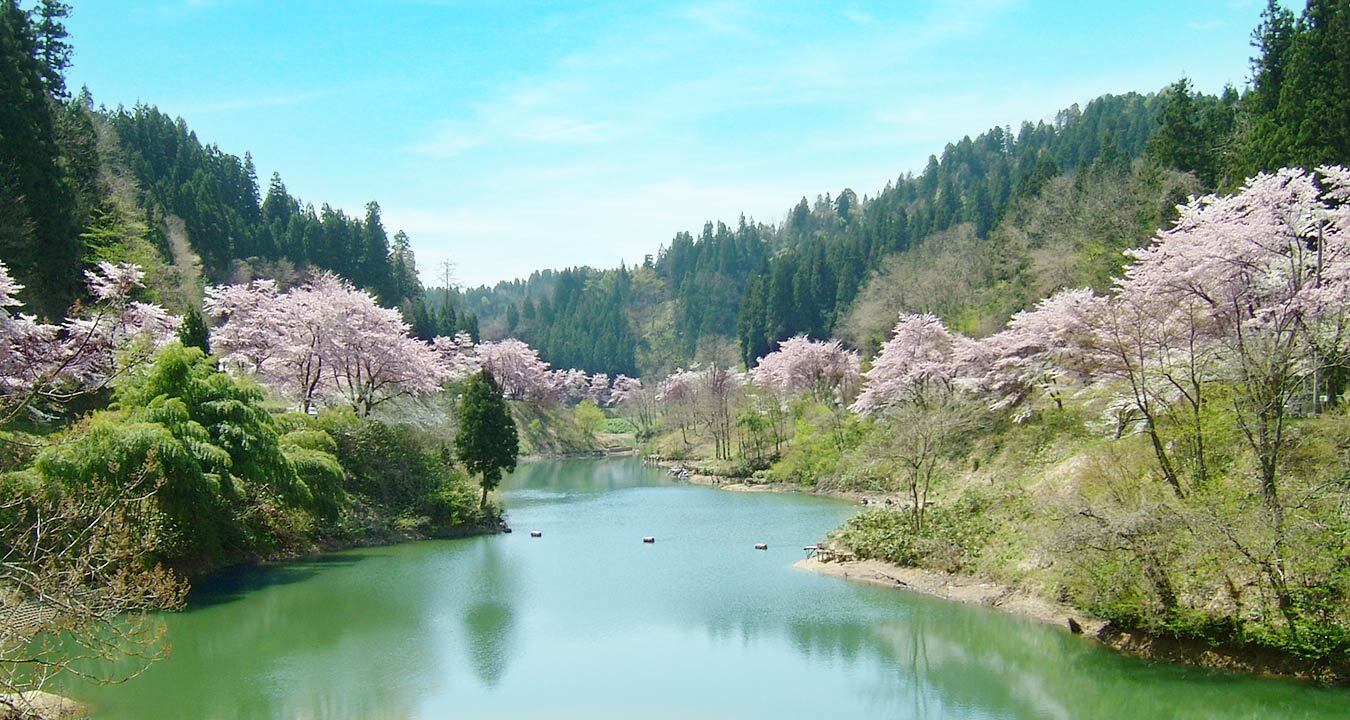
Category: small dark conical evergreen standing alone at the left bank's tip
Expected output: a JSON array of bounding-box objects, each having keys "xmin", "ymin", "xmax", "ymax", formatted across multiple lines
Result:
[{"xmin": 455, "ymin": 369, "xmax": 520, "ymax": 508}]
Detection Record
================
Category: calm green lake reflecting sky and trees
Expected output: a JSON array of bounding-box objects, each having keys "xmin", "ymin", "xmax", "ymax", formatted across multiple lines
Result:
[{"xmin": 60, "ymin": 459, "xmax": 1350, "ymax": 720}]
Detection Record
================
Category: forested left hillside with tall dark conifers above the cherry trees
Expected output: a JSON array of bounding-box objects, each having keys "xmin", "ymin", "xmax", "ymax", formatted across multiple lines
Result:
[{"xmin": 0, "ymin": 0, "xmax": 477, "ymax": 339}]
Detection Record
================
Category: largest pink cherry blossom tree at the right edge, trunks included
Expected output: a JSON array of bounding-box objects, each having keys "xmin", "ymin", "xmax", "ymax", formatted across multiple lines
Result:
[{"xmin": 1074, "ymin": 168, "xmax": 1350, "ymax": 635}]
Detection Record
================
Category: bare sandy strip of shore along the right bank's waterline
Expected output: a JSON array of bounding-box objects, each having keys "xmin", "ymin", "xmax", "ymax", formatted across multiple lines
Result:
[{"xmin": 792, "ymin": 559, "xmax": 1106, "ymax": 636}]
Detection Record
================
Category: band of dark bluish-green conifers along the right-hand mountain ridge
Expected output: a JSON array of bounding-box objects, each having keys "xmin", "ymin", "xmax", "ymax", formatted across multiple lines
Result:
[{"xmin": 466, "ymin": 93, "xmax": 1182, "ymax": 374}]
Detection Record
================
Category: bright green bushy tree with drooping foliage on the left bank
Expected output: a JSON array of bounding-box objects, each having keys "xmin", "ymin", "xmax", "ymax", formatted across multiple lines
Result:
[{"xmin": 9, "ymin": 344, "xmax": 353, "ymax": 569}]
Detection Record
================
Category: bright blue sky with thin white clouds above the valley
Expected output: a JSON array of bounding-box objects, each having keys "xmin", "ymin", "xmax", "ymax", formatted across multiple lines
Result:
[{"xmin": 69, "ymin": 0, "xmax": 1264, "ymax": 285}]
